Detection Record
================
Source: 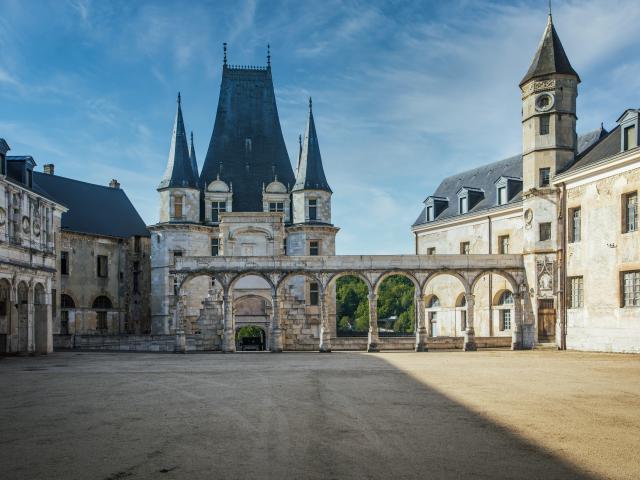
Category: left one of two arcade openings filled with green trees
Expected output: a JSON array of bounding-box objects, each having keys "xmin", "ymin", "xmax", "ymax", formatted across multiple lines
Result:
[{"xmin": 331, "ymin": 273, "xmax": 369, "ymax": 337}]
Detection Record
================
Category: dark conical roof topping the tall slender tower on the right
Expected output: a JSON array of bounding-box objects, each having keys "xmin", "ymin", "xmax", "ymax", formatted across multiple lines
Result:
[{"xmin": 520, "ymin": 14, "xmax": 580, "ymax": 86}]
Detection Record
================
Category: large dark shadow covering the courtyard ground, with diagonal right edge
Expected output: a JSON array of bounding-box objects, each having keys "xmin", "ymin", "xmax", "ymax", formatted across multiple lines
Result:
[{"xmin": 0, "ymin": 353, "xmax": 596, "ymax": 479}]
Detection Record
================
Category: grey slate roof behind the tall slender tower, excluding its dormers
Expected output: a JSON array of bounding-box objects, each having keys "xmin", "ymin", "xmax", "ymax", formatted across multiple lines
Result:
[{"xmin": 413, "ymin": 128, "xmax": 611, "ymax": 227}]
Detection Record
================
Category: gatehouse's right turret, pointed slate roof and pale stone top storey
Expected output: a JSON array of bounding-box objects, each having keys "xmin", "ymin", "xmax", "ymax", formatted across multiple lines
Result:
[{"xmin": 292, "ymin": 98, "xmax": 332, "ymax": 224}]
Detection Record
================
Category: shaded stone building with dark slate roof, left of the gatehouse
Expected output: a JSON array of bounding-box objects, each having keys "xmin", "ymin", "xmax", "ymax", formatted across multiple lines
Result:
[{"xmin": 33, "ymin": 164, "xmax": 151, "ymax": 340}]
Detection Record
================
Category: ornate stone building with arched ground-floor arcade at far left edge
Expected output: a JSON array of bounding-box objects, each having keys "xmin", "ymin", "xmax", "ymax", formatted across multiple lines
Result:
[{"xmin": 0, "ymin": 138, "xmax": 65, "ymax": 353}]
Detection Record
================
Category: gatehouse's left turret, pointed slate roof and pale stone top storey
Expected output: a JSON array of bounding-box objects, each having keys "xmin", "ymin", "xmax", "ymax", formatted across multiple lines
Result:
[{"xmin": 158, "ymin": 93, "xmax": 200, "ymax": 223}]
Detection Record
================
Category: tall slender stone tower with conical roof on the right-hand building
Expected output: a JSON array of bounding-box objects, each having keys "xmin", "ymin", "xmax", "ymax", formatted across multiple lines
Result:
[{"xmin": 520, "ymin": 14, "xmax": 580, "ymax": 342}]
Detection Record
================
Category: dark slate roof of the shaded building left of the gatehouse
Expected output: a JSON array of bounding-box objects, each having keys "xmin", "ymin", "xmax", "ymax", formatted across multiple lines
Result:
[{"xmin": 33, "ymin": 172, "xmax": 149, "ymax": 238}]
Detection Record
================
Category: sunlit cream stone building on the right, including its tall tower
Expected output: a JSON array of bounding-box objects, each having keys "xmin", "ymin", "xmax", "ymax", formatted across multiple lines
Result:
[{"xmin": 412, "ymin": 15, "xmax": 640, "ymax": 352}]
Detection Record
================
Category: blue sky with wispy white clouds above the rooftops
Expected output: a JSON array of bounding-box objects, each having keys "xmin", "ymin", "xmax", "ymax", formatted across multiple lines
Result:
[{"xmin": 0, "ymin": 0, "xmax": 640, "ymax": 254}]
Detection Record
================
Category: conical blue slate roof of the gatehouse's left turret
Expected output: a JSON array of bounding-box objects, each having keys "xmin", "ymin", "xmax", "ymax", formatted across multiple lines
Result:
[{"xmin": 158, "ymin": 93, "xmax": 198, "ymax": 190}]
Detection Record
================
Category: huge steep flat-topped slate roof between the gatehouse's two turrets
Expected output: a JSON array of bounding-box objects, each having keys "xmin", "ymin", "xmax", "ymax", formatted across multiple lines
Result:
[{"xmin": 200, "ymin": 64, "xmax": 296, "ymax": 212}]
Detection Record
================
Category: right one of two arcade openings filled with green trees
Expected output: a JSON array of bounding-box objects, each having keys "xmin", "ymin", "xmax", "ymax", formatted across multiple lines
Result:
[{"xmin": 376, "ymin": 273, "xmax": 416, "ymax": 337}]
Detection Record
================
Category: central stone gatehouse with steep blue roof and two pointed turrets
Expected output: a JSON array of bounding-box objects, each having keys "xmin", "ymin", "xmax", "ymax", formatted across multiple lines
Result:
[{"xmin": 149, "ymin": 45, "xmax": 338, "ymax": 351}]
